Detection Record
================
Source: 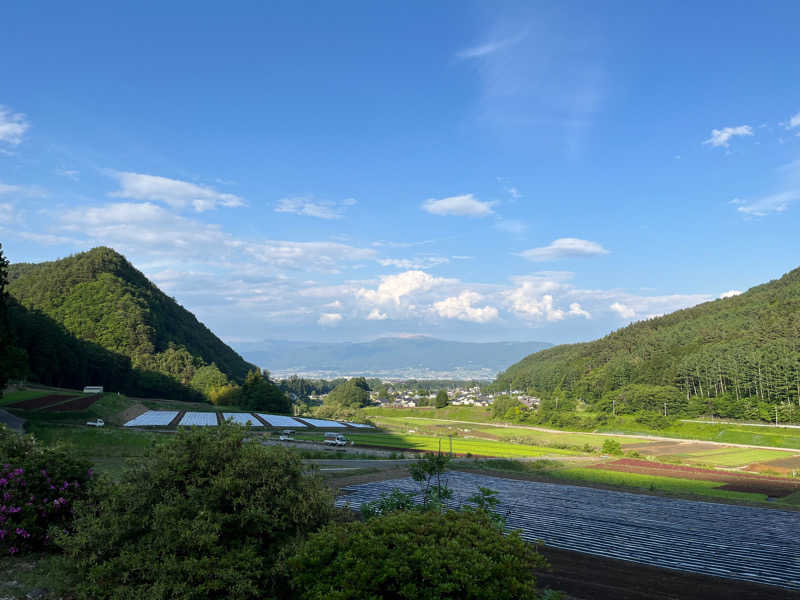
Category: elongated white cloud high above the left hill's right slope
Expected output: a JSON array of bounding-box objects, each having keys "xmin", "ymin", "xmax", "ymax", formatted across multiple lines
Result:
[{"xmin": 111, "ymin": 171, "xmax": 244, "ymax": 212}]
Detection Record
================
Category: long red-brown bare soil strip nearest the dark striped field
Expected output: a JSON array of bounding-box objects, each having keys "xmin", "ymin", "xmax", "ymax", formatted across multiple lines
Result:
[{"xmin": 589, "ymin": 458, "xmax": 800, "ymax": 498}]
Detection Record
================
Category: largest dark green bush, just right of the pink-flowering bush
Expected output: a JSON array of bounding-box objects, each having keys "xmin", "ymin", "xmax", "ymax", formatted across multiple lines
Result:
[{"xmin": 57, "ymin": 424, "xmax": 334, "ymax": 600}]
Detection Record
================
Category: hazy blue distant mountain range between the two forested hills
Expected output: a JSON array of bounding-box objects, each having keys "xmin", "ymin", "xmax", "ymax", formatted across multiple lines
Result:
[{"xmin": 234, "ymin": 336, "xmax": 552, "ymax": 379}]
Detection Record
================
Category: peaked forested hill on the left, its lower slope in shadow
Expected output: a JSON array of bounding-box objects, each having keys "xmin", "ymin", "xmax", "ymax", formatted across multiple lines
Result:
[{"xmin": 8, "ymin": 248, "xmax": 253, "ymax": 397}]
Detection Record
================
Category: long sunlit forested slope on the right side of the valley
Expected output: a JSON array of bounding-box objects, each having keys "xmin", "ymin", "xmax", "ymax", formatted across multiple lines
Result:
[{"xmin": 495, "ymin": 269, "xmax": 800, "ymax": 421}]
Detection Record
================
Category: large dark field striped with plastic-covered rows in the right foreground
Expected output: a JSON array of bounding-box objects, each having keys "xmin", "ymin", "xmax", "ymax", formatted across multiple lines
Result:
[{"xmin": 336, "ymin": 472, "xmax": 800, "ymax": 590}]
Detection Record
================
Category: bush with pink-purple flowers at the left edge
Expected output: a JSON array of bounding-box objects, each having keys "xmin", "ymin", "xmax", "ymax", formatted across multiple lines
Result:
[{"xmin": 0, "ymin": 425, "xmax": 92, "ymax": 555}]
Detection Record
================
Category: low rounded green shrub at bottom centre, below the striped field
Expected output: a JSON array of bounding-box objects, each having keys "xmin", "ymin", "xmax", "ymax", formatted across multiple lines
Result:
[{"xmin": 286, "ymin": 511, "xmax": 545, "ymax": 600}]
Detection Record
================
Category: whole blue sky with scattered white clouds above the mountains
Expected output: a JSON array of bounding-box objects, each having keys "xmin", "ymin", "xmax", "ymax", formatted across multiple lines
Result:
[{"xmin": 0, "ymin": 1, "xmax": 800, "ymax": 343}]
